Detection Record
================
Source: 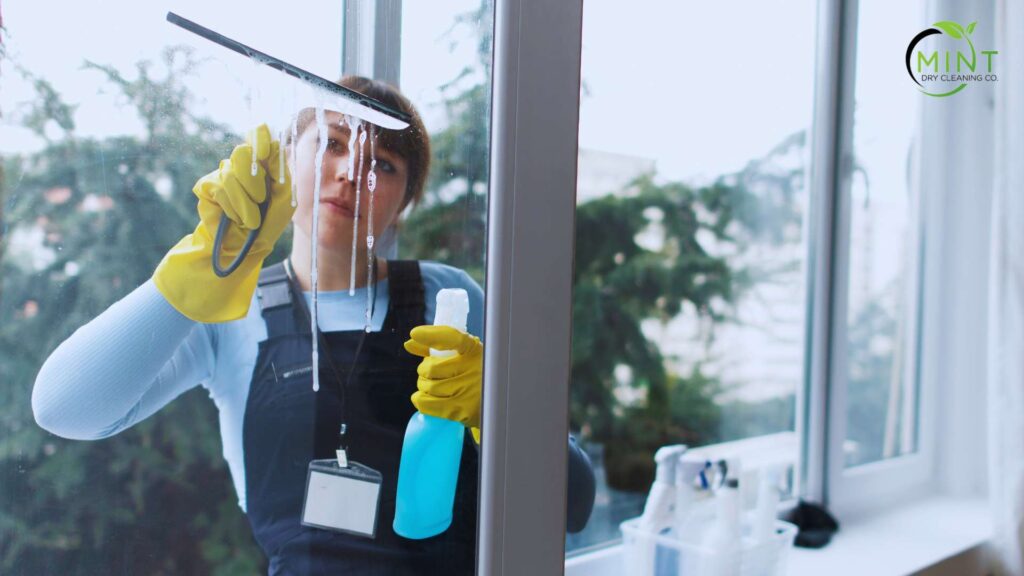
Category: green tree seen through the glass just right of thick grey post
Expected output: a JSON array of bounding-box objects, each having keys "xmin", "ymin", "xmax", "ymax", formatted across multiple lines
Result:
[{"xmin": 569, "ymin": 176, "xmax": 741, "ymax": 490}]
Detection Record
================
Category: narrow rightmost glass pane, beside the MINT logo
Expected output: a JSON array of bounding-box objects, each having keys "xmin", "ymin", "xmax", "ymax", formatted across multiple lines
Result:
[{"xmin": 844, "ymin": 2, "xmax": 922, "ymax": 466}]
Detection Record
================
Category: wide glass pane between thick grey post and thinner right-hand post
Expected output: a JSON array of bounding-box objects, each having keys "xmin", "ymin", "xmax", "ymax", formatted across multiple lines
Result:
[{"xmin": 566, "ymin": 1, "xmax": 815, "ymax": 551}]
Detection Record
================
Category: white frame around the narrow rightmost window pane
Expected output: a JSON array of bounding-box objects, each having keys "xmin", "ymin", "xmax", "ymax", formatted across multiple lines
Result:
[{"xmin": 804, "ymin": 0, "xmax": 934, "ymax": 518}]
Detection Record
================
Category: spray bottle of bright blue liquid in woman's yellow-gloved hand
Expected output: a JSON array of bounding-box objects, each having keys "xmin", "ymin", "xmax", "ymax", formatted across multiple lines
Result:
[{"xmin": 392, "ymin": 288, "xmax": 469, "ymax": 540}]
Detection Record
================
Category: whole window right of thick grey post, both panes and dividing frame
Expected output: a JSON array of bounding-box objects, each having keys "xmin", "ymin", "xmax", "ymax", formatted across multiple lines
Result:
[{"xmin": 566, "ymin": 2, "xmax": 929, "ymax": 553}]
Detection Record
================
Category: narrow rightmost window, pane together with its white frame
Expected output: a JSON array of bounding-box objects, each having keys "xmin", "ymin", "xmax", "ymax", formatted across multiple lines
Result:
[{"xmin": 809, "ymin": 2, "xmax": 945, "ymax": 515}]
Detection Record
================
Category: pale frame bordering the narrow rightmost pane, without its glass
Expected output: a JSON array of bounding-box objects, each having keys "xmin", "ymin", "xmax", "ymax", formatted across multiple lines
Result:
[{"xmin": 804, "ymin": 0, "xmax": 945, "ymax": 518}]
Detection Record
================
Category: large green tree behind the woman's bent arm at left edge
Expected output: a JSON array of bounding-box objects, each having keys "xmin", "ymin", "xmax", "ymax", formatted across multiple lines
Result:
[{"xmin": 0, "ymin": 49, "xmax": 265, "ymax": 575}]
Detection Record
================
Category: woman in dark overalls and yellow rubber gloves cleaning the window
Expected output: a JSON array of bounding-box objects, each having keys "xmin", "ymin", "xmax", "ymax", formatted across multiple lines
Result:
[{"xmin": 33, "ymin": 77, "xmax": 594, "ymax": 574}]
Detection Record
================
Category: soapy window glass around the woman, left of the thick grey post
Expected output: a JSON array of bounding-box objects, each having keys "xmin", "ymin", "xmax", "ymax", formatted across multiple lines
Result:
[{"xmin": 0, "ymin": 1, "xmax": 494, "ymax": 574}]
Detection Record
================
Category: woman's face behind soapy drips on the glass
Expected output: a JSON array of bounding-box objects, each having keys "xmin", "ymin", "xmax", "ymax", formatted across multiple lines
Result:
[{"xmin": 290, "ymin": 111, "xmax": 409, "ymax": 250}]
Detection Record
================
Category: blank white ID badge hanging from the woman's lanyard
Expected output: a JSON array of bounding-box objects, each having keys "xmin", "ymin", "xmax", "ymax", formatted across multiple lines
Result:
[{"xmin": 302, "ymin": 458, "xmax": 382, "ymax": 538}]
